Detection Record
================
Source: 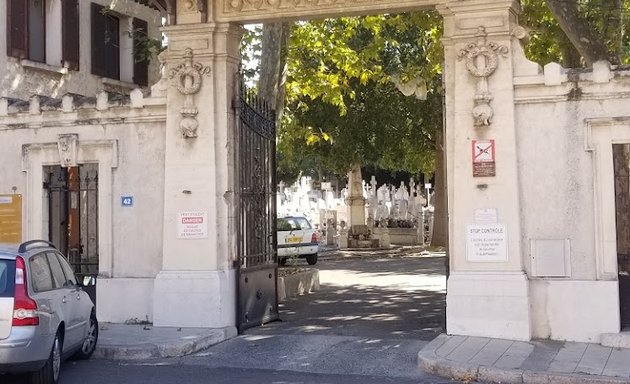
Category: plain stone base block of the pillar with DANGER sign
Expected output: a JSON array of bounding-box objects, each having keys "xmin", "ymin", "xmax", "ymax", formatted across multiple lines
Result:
[{"xmin": 153, "ymin": 270, "xmax": 236, "ymax": 328}]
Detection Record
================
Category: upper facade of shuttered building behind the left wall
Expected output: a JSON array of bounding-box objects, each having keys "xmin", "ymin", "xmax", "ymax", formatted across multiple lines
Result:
[{"xmin": 0, "ymin": 0, "xmax": 162, "ymax": 99}]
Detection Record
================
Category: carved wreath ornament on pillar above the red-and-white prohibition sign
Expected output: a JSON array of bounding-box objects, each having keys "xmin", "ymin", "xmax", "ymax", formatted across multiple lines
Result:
[{"xmin": 457, "ymin": 27, "xmax": 509, "ymax": 127}]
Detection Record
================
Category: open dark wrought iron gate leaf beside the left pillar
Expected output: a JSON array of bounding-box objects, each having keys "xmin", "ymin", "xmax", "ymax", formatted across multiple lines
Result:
[{"xmin": 235, "ymin": 82, "xmax": 278, "ymax": 332}]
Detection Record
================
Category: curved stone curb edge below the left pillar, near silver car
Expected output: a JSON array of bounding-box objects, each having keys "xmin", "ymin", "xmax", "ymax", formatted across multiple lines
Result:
[{"xmin": 92, "ymin": 327, "xmax": 237, "ymax": 360}]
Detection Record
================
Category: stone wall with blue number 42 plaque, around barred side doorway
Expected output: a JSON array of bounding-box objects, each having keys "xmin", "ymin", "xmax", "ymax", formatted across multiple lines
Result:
[{"xmin": 0, "ymin": 90, "xmax": 166, "ymax": 322}]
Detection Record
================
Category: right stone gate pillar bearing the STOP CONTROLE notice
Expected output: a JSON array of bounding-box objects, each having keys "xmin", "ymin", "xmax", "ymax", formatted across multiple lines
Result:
[{"xmin": 438, "ymin": 0, "xmax": 531, "ymax": 340}]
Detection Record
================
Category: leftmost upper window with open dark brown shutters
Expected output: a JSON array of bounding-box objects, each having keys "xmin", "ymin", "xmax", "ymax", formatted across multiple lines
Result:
[{"xmin": 6, "ymin": 0, "xmax": 79, "ymax": 70}]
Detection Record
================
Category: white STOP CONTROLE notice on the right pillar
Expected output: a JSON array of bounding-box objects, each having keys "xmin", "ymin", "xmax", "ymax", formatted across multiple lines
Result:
[{"xmin": 466, "ymin": 224, "xmax": 507, "ymax": 262}]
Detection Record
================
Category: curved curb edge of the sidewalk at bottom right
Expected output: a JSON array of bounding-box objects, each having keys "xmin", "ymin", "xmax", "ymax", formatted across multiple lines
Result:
[{"xmin": 418, "ymin": 334, "xmax": 630, "ymax": 384}]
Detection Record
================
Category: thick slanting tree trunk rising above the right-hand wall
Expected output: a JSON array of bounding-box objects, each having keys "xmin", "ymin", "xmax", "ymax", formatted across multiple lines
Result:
[{"xmin": 547, "ymin": 0, "xmax": 619, "ymax": 66}]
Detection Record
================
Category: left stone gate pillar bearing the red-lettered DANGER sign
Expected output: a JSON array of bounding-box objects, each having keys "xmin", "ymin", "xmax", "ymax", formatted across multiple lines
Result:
[{"xmin": 152, "ymin": 9, "xmax": 241, "ymax": 329}]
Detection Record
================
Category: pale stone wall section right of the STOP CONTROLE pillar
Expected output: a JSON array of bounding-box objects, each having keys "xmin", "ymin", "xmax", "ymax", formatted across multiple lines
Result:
[{"xmin": 516, "ymin": 62, "xmax": 630, "ymax": 342}]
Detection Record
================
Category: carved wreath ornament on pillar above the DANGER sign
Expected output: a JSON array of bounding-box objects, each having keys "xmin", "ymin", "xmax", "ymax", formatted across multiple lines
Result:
[{"xmin": 169, "ymin": 48, "xmax": 210, "ymax": 138}]
